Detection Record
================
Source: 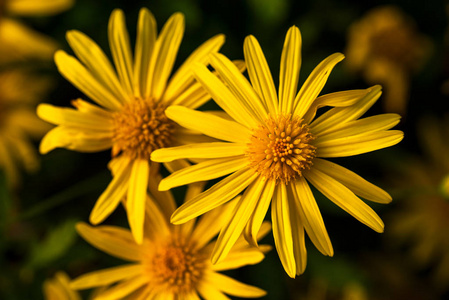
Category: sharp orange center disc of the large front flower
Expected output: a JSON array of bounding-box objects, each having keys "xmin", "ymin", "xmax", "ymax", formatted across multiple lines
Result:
[{"xmin": 247, "ymin": 115, "xmax": 316, "ymax": 183}]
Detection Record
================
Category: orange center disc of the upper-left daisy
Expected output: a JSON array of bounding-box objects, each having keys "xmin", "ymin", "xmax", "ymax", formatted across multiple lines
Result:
[{"xmin": 112, "ymin": 98, "xmax": 175, "ymax": 160}]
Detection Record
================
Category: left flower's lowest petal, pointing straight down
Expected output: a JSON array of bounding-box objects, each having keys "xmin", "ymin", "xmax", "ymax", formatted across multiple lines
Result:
[{"xmin": 126, "ymin": 159, "xmax": 150, "ymax": 244}]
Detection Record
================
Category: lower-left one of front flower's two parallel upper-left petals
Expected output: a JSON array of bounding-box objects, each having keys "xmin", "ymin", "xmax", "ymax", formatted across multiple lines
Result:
[{"xmin": 194, "ymin": 64, "xmax": 259, "ymax": 129}]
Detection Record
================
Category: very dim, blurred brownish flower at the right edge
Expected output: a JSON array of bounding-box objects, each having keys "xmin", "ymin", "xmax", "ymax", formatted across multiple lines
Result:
[{"xmin": 388, "ymin": 118, "xmax": 449, "ymax": 289}]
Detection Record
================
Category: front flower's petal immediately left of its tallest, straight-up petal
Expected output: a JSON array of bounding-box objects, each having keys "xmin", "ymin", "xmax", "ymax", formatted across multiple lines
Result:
[{"xmin": 243, "ymin": 35, "xmax": 278, "ymax": 114}]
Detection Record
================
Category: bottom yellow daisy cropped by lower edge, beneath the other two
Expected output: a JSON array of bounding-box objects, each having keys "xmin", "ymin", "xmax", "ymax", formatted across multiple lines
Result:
[{"xmin": 70, "ymin": 182, "xmax": 270, "ymax": 300}]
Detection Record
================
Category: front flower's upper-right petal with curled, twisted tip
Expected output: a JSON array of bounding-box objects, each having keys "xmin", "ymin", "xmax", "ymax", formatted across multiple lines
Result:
[{"xmin": 310, "ymin": 85, "xmax": 382, "ymax": 136}]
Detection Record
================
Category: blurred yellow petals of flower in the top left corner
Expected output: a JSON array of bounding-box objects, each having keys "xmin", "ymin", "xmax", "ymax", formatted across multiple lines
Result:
[{"xmin": 0, "ymin": 0, "xmax": 74, "ymax": 63}]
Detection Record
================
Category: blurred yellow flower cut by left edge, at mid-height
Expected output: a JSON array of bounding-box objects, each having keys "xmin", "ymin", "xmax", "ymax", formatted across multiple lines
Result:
[{"xmin": 0, "ymin": 68, "xmax": 51, "ymax": 187}]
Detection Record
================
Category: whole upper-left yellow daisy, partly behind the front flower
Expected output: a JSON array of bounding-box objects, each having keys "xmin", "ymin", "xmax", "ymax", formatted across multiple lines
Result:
[{"xmin": 37, "ymin": 9, "xmax": 228, "ymax": 243}]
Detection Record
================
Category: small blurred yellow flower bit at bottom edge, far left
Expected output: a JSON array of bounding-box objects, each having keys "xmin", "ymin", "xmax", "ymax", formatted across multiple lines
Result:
[{"xmin": 43, "ymin": 272, "xmax": 81, "ymax": 300}]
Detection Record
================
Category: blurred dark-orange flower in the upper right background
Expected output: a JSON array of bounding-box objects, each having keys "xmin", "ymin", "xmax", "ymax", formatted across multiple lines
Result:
[{"xmin": 346, "ymin": 6, "xmax": 431, "ymax": 115}]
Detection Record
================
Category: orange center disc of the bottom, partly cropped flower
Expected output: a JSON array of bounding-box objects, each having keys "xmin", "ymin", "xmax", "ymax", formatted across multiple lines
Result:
[{"xmin": 147, "ymin": 241, "xmax": 207, "ymax": 294}]
